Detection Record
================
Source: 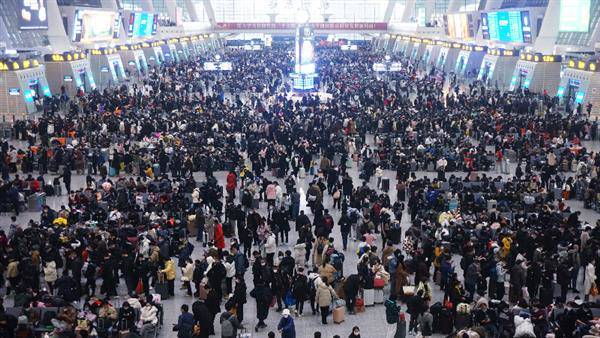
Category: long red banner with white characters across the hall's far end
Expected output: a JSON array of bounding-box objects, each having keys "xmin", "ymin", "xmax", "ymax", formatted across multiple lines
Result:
[{"xmin": 216, "ymin": 22, "xmax": 388, "ymax": 31}]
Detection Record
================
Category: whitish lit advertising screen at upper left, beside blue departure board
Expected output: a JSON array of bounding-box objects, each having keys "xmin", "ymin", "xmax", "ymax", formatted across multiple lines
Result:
[{"xmin": 72, "ymin": 9, "xmax": 121, "ymax": 42}]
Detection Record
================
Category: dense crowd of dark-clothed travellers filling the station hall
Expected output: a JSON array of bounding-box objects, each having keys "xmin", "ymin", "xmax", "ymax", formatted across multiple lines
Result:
[{"xmin": 0, "ymin": 37, "xmax": 600, "ymax": 338}]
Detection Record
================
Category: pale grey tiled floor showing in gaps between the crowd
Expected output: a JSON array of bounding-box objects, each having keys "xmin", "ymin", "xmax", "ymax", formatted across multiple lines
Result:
[{"xmin": 0, "ymin": 137, "xmax": 600, "ymax": 338}]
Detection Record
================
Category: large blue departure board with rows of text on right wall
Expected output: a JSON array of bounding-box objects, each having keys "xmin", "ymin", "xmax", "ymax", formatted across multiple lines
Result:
[{"xmin": 482, "ymin": 11, "xmax": 531, "ymax": 42}]
